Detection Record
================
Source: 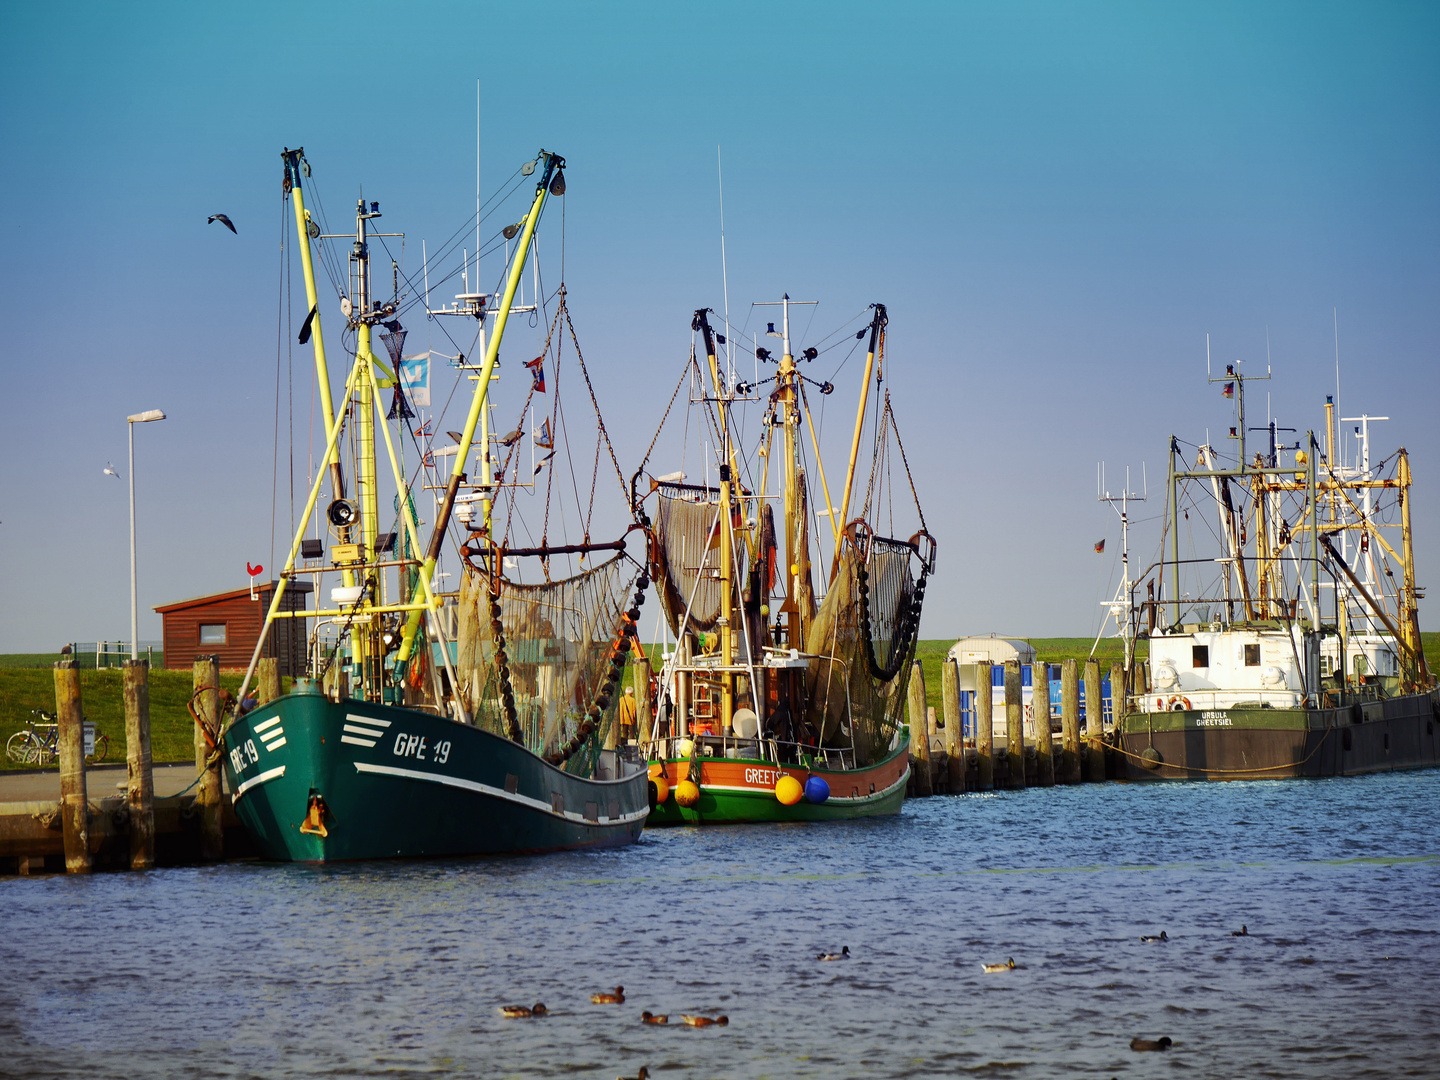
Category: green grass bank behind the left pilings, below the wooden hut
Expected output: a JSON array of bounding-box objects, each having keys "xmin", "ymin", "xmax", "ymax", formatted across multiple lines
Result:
[{"xmin": 0, "ymin": 661, "xmax": 250, "ymax": 769}]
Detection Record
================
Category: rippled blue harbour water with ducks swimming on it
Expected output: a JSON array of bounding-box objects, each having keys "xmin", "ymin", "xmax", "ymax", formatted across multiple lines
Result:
[{"xmin": 0, "ymin": 770, "xmax": 1440, "ymax": 1080}]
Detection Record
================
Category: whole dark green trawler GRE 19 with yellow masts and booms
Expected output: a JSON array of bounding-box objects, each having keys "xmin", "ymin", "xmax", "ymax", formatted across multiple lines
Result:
[{"xmin": 220, "ymin": 150, "xmax": 649, "ymax": 861}]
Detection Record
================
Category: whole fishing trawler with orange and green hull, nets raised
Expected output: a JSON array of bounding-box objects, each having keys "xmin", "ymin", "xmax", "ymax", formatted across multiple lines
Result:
[{"xmin": 632, "ymin": 297, "xmax": 935, "ymax": 825}]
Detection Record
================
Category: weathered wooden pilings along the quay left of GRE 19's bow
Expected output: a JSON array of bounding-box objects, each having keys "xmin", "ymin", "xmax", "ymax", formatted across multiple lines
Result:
[{"xmin": 39, "ymin": 657, "xmax": 281, "ymax": 874}]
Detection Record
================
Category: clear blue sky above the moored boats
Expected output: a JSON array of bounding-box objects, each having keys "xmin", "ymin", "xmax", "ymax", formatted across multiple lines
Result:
[{"xmin": 0, "ymin": 3, "xmax": 1440, "ymax": 652}]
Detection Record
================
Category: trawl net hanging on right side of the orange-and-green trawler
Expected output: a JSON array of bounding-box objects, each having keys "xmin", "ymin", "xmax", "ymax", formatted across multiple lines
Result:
[{"xmin": 806, "ymin": 537, "xmax": 914, "ymax": 765}]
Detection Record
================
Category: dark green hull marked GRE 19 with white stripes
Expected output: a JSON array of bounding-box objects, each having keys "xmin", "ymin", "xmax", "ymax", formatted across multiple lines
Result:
[{"xmin": 223, "ymin": 694, "xmax": 649, "ymax": 863}]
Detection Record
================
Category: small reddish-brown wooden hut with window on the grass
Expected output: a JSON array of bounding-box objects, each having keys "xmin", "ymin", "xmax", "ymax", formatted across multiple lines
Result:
[{"xmin": 156, "ymin": 582, "xmax": 314, "ymax": 675}]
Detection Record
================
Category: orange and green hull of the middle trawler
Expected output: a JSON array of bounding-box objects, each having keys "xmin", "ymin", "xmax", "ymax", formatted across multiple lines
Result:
[{"xmin": 648, "ymin": 747, "xmax": 910, "ymax": 827}]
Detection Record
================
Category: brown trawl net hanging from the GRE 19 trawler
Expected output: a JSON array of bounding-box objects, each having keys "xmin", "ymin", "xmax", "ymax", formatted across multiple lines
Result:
[{"xmin": 455, "ymin": 554, "xmax": 639, "ymax": 773}]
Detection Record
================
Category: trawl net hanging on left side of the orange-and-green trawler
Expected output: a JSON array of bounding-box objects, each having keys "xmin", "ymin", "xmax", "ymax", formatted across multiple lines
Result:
[{"xmin": 655, "ymin": 484, "xmax": 746, "ymax": 635}]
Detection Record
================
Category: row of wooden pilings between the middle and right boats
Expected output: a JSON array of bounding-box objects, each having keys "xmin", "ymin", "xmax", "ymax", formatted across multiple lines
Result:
[{"xmin": 907, "ymin": 657, "xmax": 1126, "ymax": 796}]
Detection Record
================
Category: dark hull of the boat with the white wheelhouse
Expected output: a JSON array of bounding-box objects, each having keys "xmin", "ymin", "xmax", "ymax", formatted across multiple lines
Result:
[{"xmin": 1120, "ymin": 690, "xmax": 1440, "ymax": 780}]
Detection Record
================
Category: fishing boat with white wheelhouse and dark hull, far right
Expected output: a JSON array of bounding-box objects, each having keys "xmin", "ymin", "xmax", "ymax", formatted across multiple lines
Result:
[{"xmin": 1115, "ymin": 366, "xmax": 1440, "ymax": 779}]
